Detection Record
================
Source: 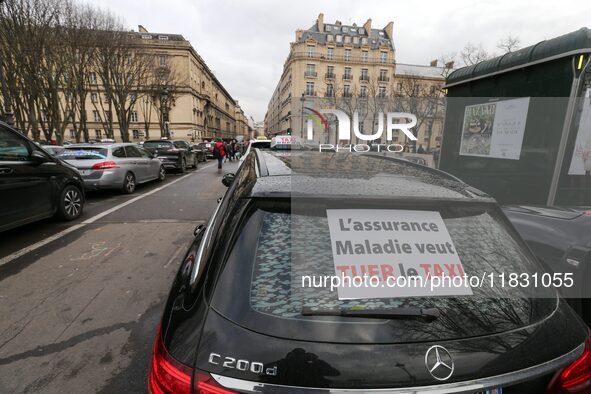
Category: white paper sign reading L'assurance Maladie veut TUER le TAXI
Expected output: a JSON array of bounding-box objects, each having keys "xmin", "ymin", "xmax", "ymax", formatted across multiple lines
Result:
[{"xmin": 326, "ymin": 209, "xmax": 472, "ymax": 299}]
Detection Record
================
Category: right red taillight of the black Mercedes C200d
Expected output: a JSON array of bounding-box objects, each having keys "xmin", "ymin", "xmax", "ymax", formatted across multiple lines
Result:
[{"xmin": 547, "ymin": 334, "xmax": 591, "ymax": 394}]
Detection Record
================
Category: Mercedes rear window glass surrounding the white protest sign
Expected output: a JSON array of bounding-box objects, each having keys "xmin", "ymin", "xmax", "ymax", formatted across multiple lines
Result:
[{"xmin": 214, "ymin": 202, "xmax": 547, "ymax": 341}]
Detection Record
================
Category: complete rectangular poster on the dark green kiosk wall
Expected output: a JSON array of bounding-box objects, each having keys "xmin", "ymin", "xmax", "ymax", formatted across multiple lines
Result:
[{"xmin": 460, "ymin": 97, "xmax": 529, "ymax": 160}]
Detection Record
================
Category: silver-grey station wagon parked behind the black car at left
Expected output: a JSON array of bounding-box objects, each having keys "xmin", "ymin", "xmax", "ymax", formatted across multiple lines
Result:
[{"xmin": 58, "ymin": 143, "xmax": 166, "ymax": 194}]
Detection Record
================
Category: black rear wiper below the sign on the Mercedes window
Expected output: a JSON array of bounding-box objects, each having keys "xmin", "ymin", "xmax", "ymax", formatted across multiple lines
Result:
[{"xmin": 301, "ymin": 306, "xmax": 440, "ymax": 322}]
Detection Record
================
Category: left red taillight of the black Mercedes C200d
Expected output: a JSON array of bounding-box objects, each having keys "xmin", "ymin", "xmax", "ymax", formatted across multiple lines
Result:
[{"xmin": 148, "ymin": 326, "xmax": 193, "ymax": 394}]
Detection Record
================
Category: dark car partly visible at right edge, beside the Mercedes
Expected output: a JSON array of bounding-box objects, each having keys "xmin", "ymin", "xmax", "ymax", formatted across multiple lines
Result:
[{"xmin": 503, "ymin": 205, "xmax": 591, "ymax": 325}]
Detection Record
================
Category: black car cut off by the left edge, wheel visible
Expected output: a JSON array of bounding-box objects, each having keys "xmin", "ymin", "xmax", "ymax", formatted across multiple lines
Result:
[{"xmin": 0, "ymin": 122, "xmax": 84, "ymax": 231}]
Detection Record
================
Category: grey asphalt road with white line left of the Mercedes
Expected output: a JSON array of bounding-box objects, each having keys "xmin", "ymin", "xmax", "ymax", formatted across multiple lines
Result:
[{"xmin": 0, "ymin": 161, "xmax": 237, "ymax": 393}]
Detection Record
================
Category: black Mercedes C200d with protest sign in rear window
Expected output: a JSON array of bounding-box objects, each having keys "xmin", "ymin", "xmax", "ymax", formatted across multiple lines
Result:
[{"xmin": 148, "ymin": 149, "xmax": 591, "ymax": 394}]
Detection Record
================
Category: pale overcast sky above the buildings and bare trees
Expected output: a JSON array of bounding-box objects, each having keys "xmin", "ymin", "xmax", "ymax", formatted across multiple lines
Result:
[{"xmin": 86, "ymin": 0, "xmax": 591, "ymax": 121}]
